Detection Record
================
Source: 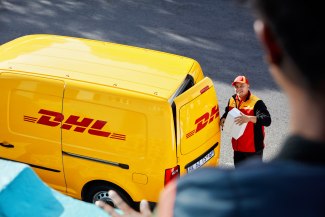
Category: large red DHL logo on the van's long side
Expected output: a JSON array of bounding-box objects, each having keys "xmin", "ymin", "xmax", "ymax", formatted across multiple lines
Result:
[{"xmin": 24, "ymin": 109, "xmax": 126, "ymax": 140}]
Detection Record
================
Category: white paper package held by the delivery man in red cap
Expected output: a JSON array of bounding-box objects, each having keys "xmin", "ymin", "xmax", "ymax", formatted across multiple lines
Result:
[{"xmin": 223, "ymin": 108, "xmax": 247, "ymax": 139}]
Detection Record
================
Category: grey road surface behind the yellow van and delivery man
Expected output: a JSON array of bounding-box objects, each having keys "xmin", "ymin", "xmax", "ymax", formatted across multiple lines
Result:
[{"xmin": 0, "ymin": 0, "xmax": 289, "ymax": 167}]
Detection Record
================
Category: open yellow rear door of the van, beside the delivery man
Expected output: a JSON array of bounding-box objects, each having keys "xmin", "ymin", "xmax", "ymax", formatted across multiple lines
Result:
[{"xmin": 174, "ymin": 77, "xmax": 220, "ymax": 173}]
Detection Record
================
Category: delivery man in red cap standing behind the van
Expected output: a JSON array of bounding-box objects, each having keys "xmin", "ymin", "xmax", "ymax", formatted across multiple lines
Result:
[{"xmin": 220, "ymin": 75, "xmax": 271, "ymax": 167}]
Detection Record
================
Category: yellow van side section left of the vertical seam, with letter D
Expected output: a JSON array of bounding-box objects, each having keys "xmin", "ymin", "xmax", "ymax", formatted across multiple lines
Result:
[{"xmin": 0, "ymin": 73, "xmax": 66, "ymax": 192}]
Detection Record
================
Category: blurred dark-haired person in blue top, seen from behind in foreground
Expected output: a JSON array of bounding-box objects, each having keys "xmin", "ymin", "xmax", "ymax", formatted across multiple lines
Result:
[{"xmin": 98, "ymin": 0, "xmax": 325, "ymax": 217}]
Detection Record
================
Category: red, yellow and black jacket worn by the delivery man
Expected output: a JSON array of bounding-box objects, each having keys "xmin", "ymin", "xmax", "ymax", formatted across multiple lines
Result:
[{"xmin": 221, "ymin": 92, "xmax": 271, "ymax": 152}]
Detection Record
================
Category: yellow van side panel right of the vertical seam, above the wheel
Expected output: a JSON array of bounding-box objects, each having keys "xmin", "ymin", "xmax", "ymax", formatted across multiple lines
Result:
[{"xmin": 62, "ymin": 82, "xmax": 177, "ymax": 201}]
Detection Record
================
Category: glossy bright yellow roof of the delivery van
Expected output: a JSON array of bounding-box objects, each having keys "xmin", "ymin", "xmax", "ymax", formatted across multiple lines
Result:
[{"xmin": 0, "ymin": 35, "xmax": 195, "ymax": 99}]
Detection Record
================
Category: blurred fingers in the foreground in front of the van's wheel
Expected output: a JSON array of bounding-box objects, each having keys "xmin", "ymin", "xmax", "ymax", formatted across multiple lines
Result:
[{"xmin": 96, "ymin": 190, "xmax": 152, "ymax": 217}]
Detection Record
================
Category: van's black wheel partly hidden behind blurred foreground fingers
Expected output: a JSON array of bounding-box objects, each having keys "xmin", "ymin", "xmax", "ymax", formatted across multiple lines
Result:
[{"xmin": 83, "ymin": 184, "xmax": 134, "ymax": 208}]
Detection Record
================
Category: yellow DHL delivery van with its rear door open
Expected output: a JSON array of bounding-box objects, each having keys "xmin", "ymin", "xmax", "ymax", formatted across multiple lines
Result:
[{"xmin": 0, "ymin": 35, "xmax": 220, "ymax": 209}]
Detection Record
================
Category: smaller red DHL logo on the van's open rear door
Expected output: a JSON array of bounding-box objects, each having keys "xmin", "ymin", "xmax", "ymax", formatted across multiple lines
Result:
[{"xmin": 186, "ymin": 105, "xmax": 219, "ymax": 139}]
